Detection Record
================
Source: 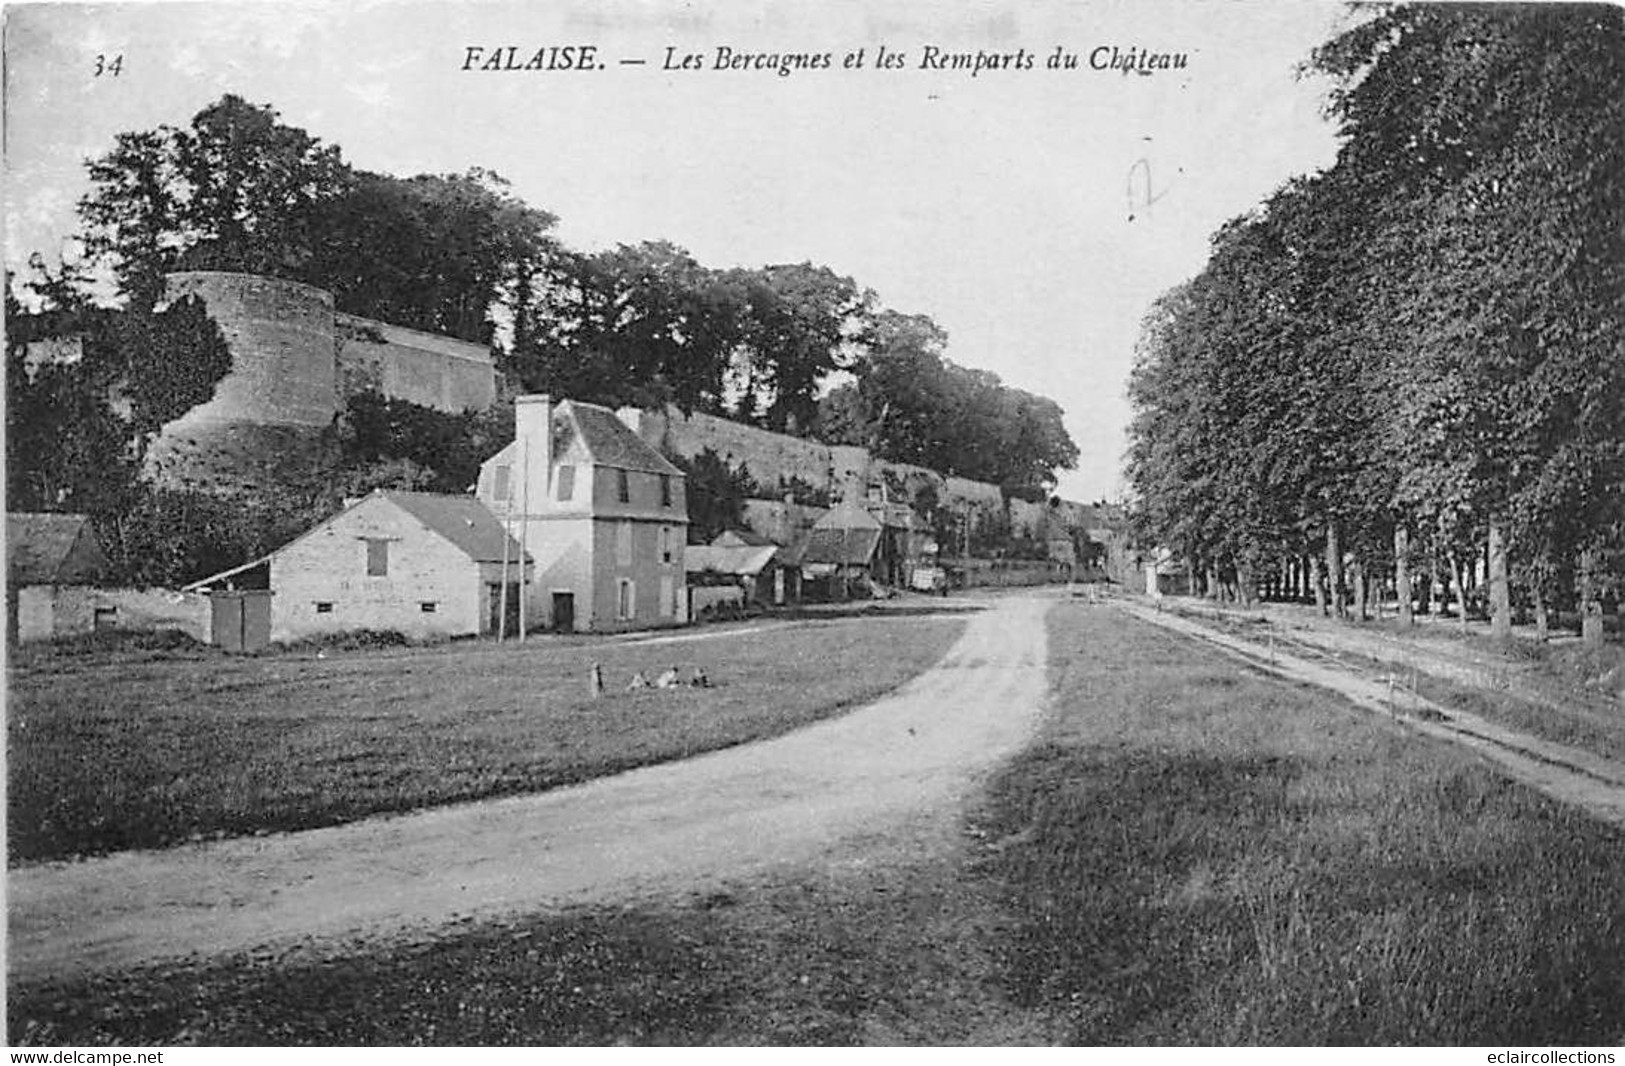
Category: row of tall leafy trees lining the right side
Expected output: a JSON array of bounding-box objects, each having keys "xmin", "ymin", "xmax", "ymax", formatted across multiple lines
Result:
[{"xmin": 1128, "ymin": 5, "xmax": 1625, "ymax": 639}]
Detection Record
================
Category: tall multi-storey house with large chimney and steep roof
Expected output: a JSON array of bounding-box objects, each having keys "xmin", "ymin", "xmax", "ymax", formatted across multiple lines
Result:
[{"xmin": 478, "ymin": 397, "xmax": 689, "ymax": 631}]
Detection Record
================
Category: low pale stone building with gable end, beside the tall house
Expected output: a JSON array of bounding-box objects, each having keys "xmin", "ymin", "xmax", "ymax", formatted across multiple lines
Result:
[{"xmin": 187, "ymin": 489, "xmax": 531, "ymax": 648}]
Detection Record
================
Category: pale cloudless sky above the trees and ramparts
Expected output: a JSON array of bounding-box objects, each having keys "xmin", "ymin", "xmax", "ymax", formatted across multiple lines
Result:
[{"xmin": 5, "ymin": 0, "xmax": 1349, "ymax": 501}]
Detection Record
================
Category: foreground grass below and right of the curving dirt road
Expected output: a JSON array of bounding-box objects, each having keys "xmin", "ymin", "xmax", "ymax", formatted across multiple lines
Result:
[{"xmin": 8, "ymin": 605, "xmax": 1625, "ymax": 1047}]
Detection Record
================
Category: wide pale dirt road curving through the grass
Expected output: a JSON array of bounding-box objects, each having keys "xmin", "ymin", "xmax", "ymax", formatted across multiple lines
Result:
[{"xmin": 7, "ymin": 595, "xmax": 1051, "ymax": 982}]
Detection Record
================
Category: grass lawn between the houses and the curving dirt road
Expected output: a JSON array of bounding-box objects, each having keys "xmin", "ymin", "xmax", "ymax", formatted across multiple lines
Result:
[{"xmin": 7, "ymin": 618, "xmax": 964, "ymax": 863}]
